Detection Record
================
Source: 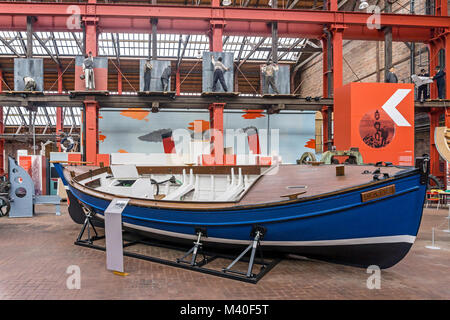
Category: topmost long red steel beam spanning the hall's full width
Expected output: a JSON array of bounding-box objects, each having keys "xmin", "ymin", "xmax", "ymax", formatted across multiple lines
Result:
[{"xmin": 0, "ymin": 2, "xmax": 450, "ymax": 31}]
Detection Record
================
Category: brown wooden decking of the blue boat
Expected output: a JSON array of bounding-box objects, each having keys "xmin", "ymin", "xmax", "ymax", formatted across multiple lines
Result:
[{"xmin": 61, "ymin": 165, "xmax": 404, "ymax": 209}]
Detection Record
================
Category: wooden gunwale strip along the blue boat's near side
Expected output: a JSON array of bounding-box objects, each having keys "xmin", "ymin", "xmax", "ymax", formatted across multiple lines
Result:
[{"xmin": 64, "ymin": 165, "xmax": 419, "ymax": 211}]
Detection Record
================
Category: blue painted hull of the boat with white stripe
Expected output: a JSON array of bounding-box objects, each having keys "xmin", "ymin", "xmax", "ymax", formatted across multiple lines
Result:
[{"xmin": 62, "ymin": 165, "xmax": 427, "ymax": 268}]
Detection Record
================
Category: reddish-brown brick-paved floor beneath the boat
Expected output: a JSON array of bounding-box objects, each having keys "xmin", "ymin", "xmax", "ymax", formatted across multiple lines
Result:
[{"xmin": 0, "ymin": 206, "xmax": 450, "ymax": 300}]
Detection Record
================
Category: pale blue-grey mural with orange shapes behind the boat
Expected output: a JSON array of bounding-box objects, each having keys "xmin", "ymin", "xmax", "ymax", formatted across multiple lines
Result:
[{"xmin": 99, "ymin": 108, "xmax": 315, "ymax": 163}]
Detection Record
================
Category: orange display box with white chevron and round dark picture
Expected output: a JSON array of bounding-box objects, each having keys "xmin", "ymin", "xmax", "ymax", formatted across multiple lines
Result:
[{"xmin": 334, "ymin": 83, "xmax": 414, "ymax": 166}]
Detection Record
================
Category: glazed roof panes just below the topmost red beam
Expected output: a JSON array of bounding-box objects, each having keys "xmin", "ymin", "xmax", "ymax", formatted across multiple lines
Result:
[{"xmin": 0, "ymin": 31, "xmax": 301, "ymax": 61}]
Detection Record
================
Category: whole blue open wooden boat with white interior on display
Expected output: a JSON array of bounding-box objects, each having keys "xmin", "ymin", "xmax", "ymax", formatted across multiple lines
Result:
[{"xmin": 54, "ymin": 158, "xmax": 429, "ymax": 268}]
